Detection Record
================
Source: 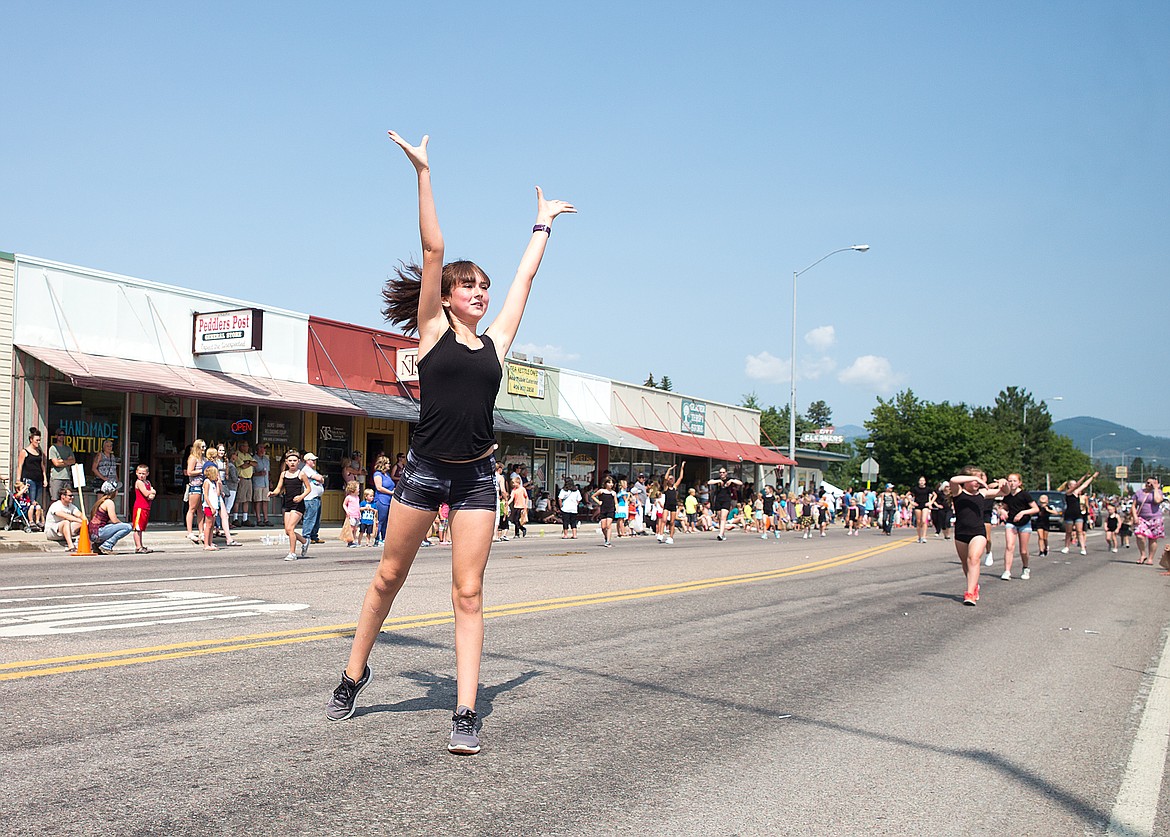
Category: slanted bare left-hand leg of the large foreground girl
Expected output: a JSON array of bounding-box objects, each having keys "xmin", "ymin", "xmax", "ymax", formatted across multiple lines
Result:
[{"xmin": 345, "ymin": 502, "xmax": 442, "ymax": 681}]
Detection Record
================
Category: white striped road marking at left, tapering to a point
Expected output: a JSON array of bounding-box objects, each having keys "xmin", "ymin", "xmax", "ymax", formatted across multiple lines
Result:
[{"xmin": 0, "ymin": 590, "xmax": 309, "ymax": 638}]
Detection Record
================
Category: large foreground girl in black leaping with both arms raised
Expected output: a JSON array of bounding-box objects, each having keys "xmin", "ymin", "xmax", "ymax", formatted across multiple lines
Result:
[{"xmin": 326, "ymin": 131, "xmax": 576, "ymax": 754}]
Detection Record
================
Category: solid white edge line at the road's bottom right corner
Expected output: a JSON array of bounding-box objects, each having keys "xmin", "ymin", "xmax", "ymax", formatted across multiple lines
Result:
[{"xmin": 1106, "ymin": 631, "xmax": 1170, "ymax": 837}]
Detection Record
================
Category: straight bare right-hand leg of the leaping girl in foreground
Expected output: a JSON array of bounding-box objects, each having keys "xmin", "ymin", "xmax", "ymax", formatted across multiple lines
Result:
[{"xmin": 450, "ymin": 509, "xmax": 493, "ymax": 709}]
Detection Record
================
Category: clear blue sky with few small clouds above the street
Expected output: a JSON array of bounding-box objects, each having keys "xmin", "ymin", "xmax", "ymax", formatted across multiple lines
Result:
[{"xmin": 0, "ymin": 0, "xmax": 1170, "ymax": 435}]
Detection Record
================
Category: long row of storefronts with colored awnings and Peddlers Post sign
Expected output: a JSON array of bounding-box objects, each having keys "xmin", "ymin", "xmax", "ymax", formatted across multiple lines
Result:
[{"xmin": 0, "ymin": 253, "xmax": 790, "ymax": 521}]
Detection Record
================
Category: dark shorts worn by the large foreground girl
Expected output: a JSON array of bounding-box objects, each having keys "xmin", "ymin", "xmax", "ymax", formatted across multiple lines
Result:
[{"xmin": 394, "ymin": 451, "xmax": 500, "ymax": 514}]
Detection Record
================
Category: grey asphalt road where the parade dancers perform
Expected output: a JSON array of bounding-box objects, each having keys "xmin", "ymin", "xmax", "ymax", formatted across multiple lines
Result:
[{"xmin": 0, "ymin": 530, "xmax": 1170, "ymax": 836}]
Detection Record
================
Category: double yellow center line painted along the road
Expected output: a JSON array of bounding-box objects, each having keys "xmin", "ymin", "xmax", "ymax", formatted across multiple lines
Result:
[{"xmin": 0, "ymin": 537, "xmax": 913, "ymax": 680}]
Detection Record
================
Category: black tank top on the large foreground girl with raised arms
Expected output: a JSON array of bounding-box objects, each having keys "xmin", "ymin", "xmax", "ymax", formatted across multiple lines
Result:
[{"xmin": 411, "ymin": 329, "xmax": 503, "ymax": 461}]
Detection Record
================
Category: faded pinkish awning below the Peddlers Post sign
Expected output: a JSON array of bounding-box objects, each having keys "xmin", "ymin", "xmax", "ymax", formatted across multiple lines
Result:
[{"xmin": 16, "ymin": 345, "xmax": 366, "ymax": 416}]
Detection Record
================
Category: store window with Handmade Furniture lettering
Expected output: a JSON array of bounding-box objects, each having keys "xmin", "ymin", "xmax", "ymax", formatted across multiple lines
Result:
[{"xmin": 42, "ymin": 383, "xmax": 126, "ymax": 488}]
